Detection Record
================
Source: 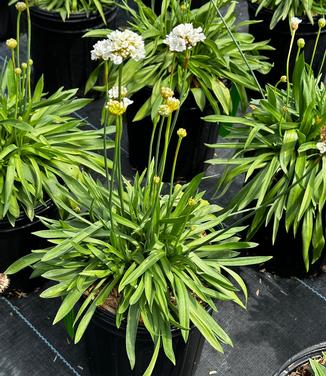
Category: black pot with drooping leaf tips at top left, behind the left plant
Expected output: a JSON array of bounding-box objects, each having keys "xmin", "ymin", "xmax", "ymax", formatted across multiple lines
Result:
[{"xmin": 10, "ymin": 0, "xmax": 116, "ymax": 95}]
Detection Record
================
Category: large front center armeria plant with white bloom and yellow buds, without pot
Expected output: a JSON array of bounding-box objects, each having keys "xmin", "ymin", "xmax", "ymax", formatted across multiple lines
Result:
[{"xmin": 7, "ymin": 22, "xmax": 266, "ymax": 375}]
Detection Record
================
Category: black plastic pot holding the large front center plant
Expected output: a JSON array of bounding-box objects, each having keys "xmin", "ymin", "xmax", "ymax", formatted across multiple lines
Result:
[{"xmin": 86, "ymin": 308, "xmax": 205, "ymax": 376}]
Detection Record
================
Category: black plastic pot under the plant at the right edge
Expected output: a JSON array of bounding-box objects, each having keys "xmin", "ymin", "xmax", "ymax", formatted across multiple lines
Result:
[{"xmin": 250, "ymin": 214, "xmax": 326, "ymax": 277}]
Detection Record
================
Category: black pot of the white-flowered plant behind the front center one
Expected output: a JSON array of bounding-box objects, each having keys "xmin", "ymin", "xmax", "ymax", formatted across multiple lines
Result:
[{"xmin": 127, "ymin": 89, "xmax": 219, "ymax": 181}]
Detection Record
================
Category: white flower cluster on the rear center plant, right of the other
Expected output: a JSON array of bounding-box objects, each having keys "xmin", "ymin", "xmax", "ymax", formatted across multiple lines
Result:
[{"xmin": 163, "ymin": 23, "xmax": 206, "ymax": 52}]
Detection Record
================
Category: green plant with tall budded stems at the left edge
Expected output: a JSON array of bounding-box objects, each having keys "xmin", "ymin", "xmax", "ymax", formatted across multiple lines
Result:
[{"xmin": 0, "ymin": 2, "xmax": 112, "ymax": 225}]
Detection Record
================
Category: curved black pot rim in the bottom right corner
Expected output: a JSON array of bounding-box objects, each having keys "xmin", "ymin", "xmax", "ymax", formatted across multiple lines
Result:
[{"xmin": 273, "ymin": 342, "xmax": 326, "ymax": 376}]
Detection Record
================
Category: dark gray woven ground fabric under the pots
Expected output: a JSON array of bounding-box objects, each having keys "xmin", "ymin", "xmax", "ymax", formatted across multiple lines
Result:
[{"xmin": 0, "ymin": 1, "xmax": 326, "ymax": 376}]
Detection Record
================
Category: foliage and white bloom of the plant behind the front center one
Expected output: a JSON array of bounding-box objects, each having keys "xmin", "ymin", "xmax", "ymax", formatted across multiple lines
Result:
[{"xmin": 86, "ymin": 0, "xmax": 271, "ymax": 116}]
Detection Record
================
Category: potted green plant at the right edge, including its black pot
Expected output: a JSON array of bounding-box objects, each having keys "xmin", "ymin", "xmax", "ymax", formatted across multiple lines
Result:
[{"xmin": 205, "ymin": 36, "xmax": 326, "ymax": 275}]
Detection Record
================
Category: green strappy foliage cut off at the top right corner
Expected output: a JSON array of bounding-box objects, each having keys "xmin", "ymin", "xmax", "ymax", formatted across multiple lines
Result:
[{"xmin": 249, "ymin": 0, "xmax": 326, "ymax": 29}]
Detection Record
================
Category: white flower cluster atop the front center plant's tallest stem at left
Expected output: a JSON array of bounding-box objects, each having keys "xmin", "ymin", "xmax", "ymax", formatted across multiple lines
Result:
[{"xmin": 91, "ymin": 30, "xmax": 145, "ymax": 65}]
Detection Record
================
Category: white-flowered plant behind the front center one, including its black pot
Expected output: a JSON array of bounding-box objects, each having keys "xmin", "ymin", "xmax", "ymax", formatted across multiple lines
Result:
[{"xmin": 87, "ymin": 1, "xmax": 269, "ymax": 181}]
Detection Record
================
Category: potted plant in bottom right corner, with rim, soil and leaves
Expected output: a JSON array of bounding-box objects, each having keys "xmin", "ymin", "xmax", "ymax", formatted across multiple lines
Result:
[{"xmin": 274, "ymin": 342, "xmax": 326, "ymax": 376}]
